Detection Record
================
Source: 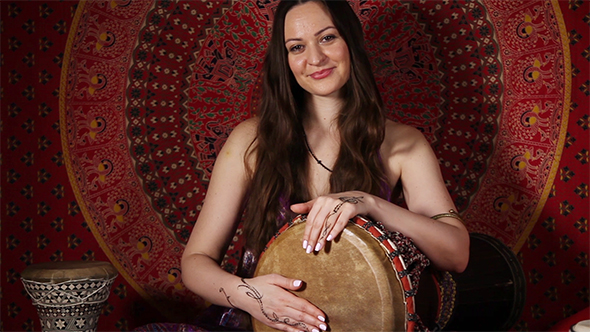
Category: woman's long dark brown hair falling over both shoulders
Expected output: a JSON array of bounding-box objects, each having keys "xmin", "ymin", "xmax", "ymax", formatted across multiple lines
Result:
[{"xmin": 244, "ymin": 0, "xmax": 390, "ymax": 254}]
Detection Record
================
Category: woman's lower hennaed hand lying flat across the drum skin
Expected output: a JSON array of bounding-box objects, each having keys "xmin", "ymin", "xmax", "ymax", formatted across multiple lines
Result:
[{"xmin": 238, "ymin": 274, "xmax": 327, "ymax": 332}]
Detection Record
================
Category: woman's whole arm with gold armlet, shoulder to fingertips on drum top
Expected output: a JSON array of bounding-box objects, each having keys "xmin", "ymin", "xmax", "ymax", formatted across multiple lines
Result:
[{"xmin": 292, "ymin": 123, "xmax": 469, "ymax": 271}]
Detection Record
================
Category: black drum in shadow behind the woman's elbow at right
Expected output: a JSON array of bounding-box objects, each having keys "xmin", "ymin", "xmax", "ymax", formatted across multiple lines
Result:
[{"xmin": 416, "ymin": 233, "xmax": 526, "ymax": 331}]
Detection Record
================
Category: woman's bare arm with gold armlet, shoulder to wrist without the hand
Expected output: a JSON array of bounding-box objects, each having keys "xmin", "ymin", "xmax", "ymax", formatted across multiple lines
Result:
[{"xmin": 372, "ymin": 120, "xmax": 469, "ymax": 271}]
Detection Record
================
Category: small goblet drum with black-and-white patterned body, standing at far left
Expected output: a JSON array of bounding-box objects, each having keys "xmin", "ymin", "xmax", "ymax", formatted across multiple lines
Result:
[{"xmin": 21, "ymin": 261, "xmax": 118, "ymax": 332}]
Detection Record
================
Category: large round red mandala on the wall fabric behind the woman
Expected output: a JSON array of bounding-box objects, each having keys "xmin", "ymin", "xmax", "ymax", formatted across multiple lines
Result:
[{"xmin": 60, "ymin": 0, "xmax": 569, "ymax": 317}]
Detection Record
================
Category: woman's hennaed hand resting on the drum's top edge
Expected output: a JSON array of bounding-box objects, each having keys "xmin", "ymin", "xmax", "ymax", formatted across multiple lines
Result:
[{"xmin": 291, "ymin": 191, "xmax": 371, "ymax": 253}]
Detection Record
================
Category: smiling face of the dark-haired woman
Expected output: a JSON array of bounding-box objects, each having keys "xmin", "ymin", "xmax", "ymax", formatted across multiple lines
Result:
[{"xmin": 285, "ymin": 1, "xmax": 350, "ymax": 97}]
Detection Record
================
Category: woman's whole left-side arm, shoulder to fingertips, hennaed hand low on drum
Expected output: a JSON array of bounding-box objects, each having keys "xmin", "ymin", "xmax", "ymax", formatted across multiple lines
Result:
[{"xmin": 182, "ymin": 120, "xmax": 327, "ymax": 332}]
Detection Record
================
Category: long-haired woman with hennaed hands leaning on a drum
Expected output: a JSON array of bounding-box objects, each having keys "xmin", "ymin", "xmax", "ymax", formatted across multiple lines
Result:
[{"xmin": 182, "ymin": 1, "xmax": 469, "ymax": 331}]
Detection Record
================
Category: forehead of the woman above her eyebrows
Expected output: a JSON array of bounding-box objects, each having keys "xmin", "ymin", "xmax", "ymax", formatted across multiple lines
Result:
[{"xmin": 285, "ymin": 1, "xmax": 334, "ymax": 38}]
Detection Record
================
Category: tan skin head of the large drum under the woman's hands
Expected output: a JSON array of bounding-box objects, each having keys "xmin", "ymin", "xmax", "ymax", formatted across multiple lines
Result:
[{"xmin": 252, "ymin": 223, "xmax": 406, "ymax": 331}]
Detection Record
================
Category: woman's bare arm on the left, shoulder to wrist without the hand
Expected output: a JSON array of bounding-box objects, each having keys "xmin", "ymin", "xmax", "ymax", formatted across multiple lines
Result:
[{"xmin": 182, "ymin": 119, "xmax": 255, "ymax": 306}]
